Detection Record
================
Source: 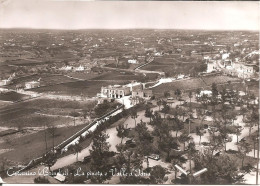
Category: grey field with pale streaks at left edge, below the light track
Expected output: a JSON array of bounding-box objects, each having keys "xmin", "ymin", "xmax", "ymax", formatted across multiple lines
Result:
[{"xmin": 0, "ymin": 99, "xmax": 95, "ymax": 128}]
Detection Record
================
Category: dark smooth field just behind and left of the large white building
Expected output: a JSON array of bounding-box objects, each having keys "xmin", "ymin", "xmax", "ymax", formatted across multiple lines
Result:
[{"xmin": 31, "ymin": 80, "xmax": 129, "ymax": 97}]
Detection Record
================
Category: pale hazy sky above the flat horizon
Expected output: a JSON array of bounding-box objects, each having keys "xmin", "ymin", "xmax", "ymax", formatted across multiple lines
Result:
[{"xmin": 0, "ymin": 0, "xmax": 260, "ymax": 30}]
